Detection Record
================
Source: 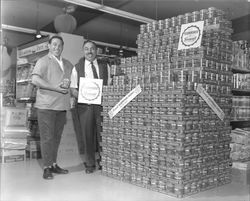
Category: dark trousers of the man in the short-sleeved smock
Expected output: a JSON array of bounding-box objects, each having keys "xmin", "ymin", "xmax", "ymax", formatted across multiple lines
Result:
[{"xmin": 37, "ymin": 109, "xmax": 66, "ymax": 167}]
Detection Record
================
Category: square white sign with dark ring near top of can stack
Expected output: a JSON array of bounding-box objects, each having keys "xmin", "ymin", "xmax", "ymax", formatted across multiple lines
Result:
[{"xmin": 178, "ymin": 21, "xmax": 204, "ymax": 50}]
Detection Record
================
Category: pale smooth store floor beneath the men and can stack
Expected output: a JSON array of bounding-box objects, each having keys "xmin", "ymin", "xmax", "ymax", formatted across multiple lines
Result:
[{"xmin": 0, "ymin": 159, "xmax": 250, "ymax": 201}]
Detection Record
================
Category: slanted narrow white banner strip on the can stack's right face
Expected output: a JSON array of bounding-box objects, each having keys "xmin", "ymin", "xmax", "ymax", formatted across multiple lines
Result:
[{"xmin": 196, "ymin": 84, "xmax": 225, "ymax": 120}]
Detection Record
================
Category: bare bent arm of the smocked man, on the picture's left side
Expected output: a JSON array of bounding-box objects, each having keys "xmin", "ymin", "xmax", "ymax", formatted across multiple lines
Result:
[{"xmin": 31, "ymin": 74, "xmax": 69, "ymax": 94}]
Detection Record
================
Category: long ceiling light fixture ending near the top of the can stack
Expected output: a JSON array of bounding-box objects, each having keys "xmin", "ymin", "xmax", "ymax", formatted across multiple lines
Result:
[{"xmin": 64, "ymin": 0, "xmax": 155, "ymax": 23}]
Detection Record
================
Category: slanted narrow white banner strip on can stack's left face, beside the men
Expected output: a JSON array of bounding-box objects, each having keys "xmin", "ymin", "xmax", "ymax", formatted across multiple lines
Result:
[{"xmin": 108, "ymin": 85, "xmax": 142, "ymax": 119}]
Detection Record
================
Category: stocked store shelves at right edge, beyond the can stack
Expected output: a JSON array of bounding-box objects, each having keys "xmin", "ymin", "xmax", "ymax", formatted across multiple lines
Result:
[{"xmin": 230, "ymin": 41, "xmax": 250, "ymax": 168}]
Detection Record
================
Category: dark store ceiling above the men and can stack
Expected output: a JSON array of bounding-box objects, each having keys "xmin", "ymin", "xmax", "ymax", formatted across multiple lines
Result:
[{"xmin": 1, "ymin": 0, "xmax": 250, "ymax": 47}]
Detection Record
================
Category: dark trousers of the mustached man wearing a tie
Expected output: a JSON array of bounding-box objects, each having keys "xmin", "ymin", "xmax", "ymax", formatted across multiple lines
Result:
[{"xmin": 76, "ymin": 104, "xmax": 101, "ymax": 166}]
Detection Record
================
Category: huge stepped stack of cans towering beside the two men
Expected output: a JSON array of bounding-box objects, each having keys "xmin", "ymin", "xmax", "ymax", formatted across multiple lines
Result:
[{"xmin": 101, "ymin": 8, "xmax": 232, "ymax": 197}]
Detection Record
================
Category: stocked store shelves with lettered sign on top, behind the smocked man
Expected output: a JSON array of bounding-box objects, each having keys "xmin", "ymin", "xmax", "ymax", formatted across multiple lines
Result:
[{"xmin": 16, "ymin": 37, "xmax": 49, "ymax": 159}]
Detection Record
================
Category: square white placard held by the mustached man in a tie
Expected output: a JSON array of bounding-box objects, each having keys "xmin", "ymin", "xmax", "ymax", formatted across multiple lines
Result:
[{"xmin": 78, "ymin": 77, "xmax": 103, "ymax": 105}]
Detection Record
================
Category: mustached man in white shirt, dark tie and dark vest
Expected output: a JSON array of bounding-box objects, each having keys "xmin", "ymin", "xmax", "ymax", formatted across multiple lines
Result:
[{"xmin": 70, "ymin": 40, "xmax": 111, "ymax": 174}]
